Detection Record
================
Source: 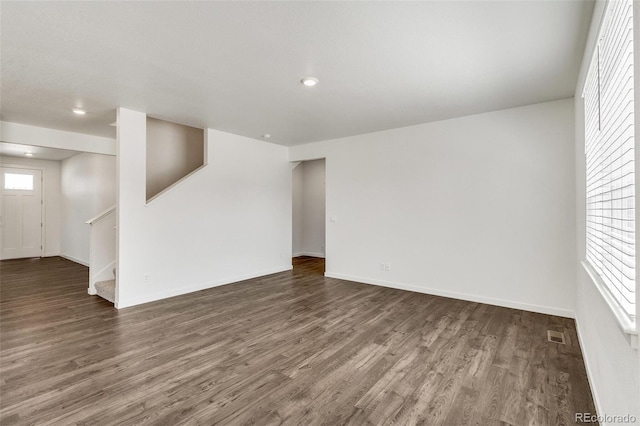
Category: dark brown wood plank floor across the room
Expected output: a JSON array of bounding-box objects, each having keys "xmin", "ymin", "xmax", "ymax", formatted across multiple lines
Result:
[{"xmin": 0, "ymin": 258, "xmax": 595, "ymax": 425}]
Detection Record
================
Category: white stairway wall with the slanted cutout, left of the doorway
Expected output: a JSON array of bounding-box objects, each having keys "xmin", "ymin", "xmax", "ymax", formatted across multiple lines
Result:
[{"xmin": 116, "ymin": 108, "xmax": 291, "ymax": 308}]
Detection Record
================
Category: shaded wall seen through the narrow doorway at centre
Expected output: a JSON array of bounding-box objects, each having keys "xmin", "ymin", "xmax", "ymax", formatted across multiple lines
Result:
[{"xmin": 293, "ymin": 159, "xmax": 325, "ymax": 257}]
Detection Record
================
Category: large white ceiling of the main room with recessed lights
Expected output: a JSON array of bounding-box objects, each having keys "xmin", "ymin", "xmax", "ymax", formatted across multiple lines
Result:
[{"xmin": 0, "ymin": 0, "xmax": 593, "ymax": 145}]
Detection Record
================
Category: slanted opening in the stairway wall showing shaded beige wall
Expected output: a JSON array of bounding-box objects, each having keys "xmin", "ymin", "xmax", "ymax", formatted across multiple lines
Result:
[{"xmin": 147, "ymin": 117, "xmax": 205, "ymax": 201}]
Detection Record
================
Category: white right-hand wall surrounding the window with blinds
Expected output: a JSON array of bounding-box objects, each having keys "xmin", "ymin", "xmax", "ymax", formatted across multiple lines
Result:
[{"xmin": 574, "ymin": 1, "xmax": 640, "ymax": 425}]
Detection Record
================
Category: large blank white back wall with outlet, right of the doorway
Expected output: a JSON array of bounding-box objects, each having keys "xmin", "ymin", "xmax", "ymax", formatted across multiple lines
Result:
[{"xmin": 290, "ymin": 99, "xmax": 576, "ymax": 317}]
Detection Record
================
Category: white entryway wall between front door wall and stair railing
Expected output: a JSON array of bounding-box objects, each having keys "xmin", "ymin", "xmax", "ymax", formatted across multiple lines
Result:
[{"xmin": 60, "ymin": 153, "xmax": 116, "ymax": 265}]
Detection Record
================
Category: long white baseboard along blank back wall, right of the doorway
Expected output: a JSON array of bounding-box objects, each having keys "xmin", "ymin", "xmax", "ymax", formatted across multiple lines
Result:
[{"xmin": 324, "ymin": 272, "xmax": 575, "ymax": 318}]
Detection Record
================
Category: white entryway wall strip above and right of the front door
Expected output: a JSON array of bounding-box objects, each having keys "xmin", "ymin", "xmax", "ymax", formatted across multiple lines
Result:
[{"xmin": 0, "ymin": 156, "xmax": 60, "ymax": 256}]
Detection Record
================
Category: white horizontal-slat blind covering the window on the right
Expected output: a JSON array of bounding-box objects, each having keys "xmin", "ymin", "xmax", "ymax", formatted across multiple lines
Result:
[{"xmin": 584, "ymin": 0, "xmax": 636, "ymax": 321}]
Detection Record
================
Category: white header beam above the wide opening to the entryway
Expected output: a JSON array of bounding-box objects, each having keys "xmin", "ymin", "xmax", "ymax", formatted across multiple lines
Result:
[{"xmin": 0, "ymin": 121, "xmax": 116, "ymax": 155}]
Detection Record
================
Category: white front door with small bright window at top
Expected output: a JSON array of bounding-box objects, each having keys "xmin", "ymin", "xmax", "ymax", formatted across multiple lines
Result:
[{"xmin": 0, "ymin": 167, "xmax": 42, "ymax": 259}]
